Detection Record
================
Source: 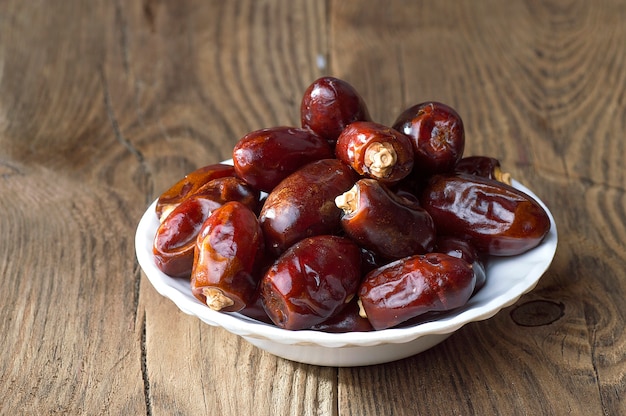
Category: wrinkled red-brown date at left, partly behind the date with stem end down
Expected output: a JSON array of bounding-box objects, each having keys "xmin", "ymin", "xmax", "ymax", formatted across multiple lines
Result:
[{"xmin": 152, "ymin": 195, "xmax": 222, "ymax": 278}]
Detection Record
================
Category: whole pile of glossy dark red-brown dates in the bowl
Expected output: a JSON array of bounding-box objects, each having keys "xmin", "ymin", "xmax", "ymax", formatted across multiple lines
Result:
[{"xmin": 153, "ymin": 77, "xmax": 550, "ymax": 332}]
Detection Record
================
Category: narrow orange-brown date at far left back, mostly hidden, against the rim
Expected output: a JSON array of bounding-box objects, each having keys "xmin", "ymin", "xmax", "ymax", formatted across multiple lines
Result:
[{"xmin": 155, "ymin": 163, "xmax": 235, "ymax": 221}]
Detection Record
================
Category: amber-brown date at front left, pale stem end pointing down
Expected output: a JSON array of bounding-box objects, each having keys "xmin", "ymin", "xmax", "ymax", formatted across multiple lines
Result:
[{"xmin": 191, "ymin": 201, "xmax": 264, "ymax": 312}]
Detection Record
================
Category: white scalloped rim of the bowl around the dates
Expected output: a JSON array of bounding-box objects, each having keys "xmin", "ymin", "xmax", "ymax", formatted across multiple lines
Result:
[{"xmin": 135, "ymin": 176, "xmax": 558, "ymax": 347}]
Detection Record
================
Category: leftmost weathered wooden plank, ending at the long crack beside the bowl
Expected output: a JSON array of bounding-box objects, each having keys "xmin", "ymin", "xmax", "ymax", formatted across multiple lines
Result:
[{"xmin": 0, "ymin": 2, "xmax": 146, "ymax": 414}]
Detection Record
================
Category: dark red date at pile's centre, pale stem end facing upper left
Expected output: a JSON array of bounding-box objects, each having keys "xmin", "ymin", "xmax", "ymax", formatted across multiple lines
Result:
[{"xmin": 335, "ymin": 179, "xmax": 436, "ymax": 260}]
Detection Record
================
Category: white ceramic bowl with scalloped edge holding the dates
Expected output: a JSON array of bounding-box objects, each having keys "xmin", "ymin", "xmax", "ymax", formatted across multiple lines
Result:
[{"xmin": 135, "ymin": 181, "xmax": 558, "ymax": 367}]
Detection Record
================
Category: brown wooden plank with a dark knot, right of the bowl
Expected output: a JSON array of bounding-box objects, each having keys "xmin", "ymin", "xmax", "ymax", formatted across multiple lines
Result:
[{"xmin": 329, "ymin": 1, "xmax": 626, "ymax": 414}]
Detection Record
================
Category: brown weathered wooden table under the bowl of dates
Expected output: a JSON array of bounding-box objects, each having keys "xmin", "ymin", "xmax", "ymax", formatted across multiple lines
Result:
[{"xmin": 0, "ymin": 0, "xmax": 626, "ymax": 415}]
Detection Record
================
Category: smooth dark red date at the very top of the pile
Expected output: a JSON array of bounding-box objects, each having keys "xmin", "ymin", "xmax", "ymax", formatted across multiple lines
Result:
[{"xmin": 300, "ymin": 77, "xmax": 371, "ymax": 145}]
